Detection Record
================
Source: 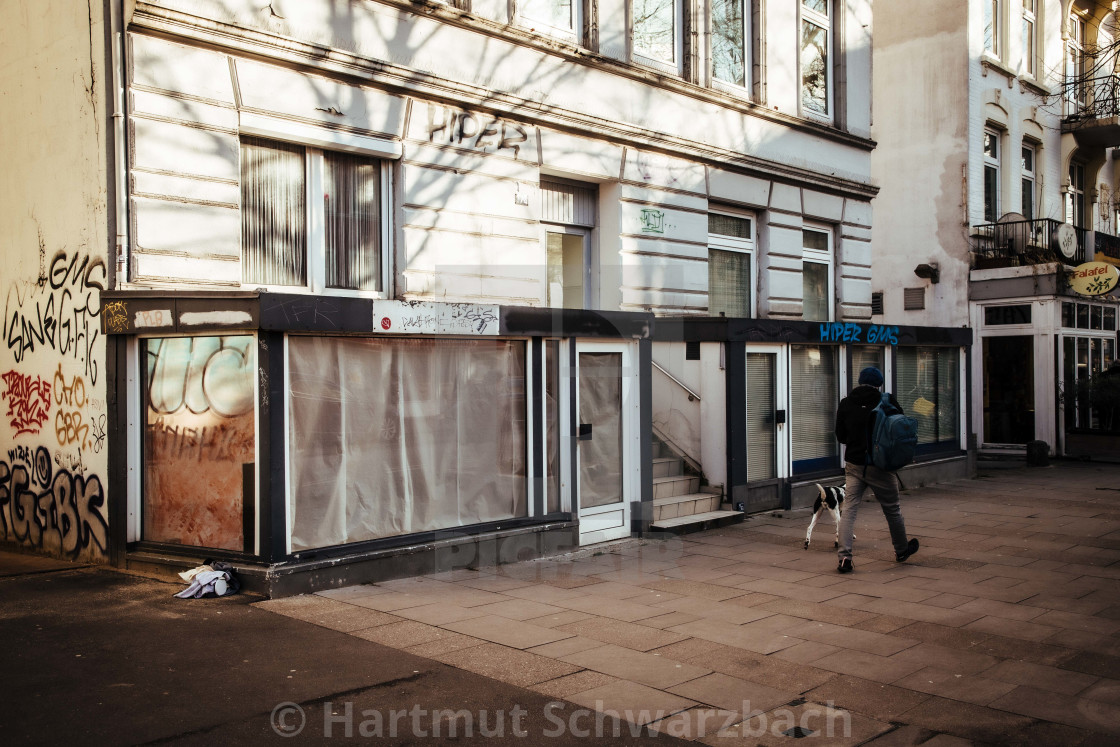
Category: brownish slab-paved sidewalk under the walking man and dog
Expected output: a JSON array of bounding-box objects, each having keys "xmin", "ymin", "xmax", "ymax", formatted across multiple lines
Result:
[{"xmin": 256, "ymin": 463, "xmax": 1120, "ymax": 747}]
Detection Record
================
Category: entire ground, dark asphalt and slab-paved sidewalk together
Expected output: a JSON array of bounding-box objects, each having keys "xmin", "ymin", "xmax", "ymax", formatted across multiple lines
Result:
[{"xmin": 0, "ymin": 464, "xmax": 1120, "ymax": 747}]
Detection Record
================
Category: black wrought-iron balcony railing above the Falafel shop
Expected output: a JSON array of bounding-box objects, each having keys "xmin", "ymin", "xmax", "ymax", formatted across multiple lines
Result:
[{"xmin": 972, "ymin": 218, "xmax": 1090, "ymax": 269}]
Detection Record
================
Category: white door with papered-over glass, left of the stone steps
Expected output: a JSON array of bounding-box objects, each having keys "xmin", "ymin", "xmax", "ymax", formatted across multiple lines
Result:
[{"xmin": 576, "ymin": 343, "xmax": 637, "ymax": 544}]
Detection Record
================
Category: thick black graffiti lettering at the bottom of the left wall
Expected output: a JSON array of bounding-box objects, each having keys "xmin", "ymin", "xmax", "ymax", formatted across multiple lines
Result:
[{"xmin": 0, "ymin": 446, "xmax": 109, "ymax": 558}]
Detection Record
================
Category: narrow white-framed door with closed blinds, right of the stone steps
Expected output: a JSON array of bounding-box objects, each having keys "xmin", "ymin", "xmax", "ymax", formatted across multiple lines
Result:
[{"xmin": 746, "ymin": 346, "xmax": 788, "ymax": 513}]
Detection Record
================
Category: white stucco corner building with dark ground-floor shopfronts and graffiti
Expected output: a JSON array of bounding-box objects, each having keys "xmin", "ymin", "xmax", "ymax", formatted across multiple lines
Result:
[{"xmin": 0, "ymin": 0, "xmax": 977, "ymax": 596}]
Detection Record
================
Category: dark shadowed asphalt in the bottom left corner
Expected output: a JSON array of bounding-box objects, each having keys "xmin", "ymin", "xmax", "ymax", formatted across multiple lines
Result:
[{"xmin": 0, "ymin": 564, "xmax": 684, "ymax": 745}]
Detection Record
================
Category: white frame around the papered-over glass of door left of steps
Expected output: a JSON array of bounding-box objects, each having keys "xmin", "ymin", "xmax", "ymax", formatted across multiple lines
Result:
[{"xmin": 571, "ymin": 340, "xmax": 642, "ymax": 545}]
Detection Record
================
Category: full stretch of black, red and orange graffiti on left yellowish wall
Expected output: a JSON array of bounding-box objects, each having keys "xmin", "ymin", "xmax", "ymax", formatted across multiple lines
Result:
[{"xmin": 0, "ymin": 248, "xmax": 109, "ymax": 559}]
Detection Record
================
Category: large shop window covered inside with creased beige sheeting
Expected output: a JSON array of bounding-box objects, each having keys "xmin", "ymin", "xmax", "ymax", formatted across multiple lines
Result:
[{"xmin": 288, "ymin": 337, "xmax": 528, "ymax": 551}]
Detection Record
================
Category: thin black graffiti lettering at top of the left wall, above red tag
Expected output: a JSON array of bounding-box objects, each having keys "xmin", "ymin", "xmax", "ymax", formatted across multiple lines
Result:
[{"xmin": 3, "ymin": 251, "xmax": 108, "ymax": 384}]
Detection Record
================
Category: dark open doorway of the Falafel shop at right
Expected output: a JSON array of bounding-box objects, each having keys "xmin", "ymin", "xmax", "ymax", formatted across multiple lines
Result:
[{"xmin": 983, "ymin": 335, "xmax": 1035, "ymax": 443}]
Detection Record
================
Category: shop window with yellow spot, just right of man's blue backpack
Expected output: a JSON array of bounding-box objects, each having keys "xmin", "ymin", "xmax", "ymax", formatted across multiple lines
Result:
[{"xmin": 895, "ymin": 347, "xmax": 961, "ymax": 449}]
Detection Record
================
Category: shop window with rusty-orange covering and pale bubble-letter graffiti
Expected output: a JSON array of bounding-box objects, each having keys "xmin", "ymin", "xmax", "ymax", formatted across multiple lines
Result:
[{"xmin": 141, "ymin": 335, "xmax": 256, "ymax": 552}]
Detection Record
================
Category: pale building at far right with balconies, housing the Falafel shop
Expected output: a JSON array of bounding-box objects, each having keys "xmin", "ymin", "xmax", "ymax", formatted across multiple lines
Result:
[{"xmin": 872, "ymin": 0, "xmax": 1120, "ymax": 457}]
